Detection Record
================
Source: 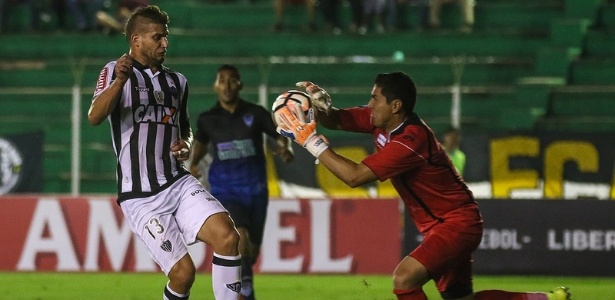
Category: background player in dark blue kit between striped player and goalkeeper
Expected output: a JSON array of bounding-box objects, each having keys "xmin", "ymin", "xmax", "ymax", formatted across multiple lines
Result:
[{"xmin": 190, "ymin": 65, "xmax": 294, "ymax": 299}]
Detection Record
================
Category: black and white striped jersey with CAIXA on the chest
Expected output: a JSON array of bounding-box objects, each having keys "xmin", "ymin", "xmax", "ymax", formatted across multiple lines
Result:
[{"xmin": 94, "ymin": 61, "xmax": 190, "ymax": 203}]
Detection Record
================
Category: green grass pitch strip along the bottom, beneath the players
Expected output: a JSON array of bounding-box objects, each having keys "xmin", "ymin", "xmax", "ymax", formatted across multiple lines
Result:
[{"xmin": 0, "ymin": 272, "xmax": 615, "ymax": 300}]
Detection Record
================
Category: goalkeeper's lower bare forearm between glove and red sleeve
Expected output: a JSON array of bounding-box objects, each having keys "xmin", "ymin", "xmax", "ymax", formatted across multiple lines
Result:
[{"xmin": 318, "ymin": 148, "xmax": 378, "ymax": 188}]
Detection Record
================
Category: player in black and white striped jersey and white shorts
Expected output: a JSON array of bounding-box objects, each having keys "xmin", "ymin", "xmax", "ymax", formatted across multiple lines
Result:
[{"xmin": 88, "ymin": 6, "xmax": 241, "ymax": 300}]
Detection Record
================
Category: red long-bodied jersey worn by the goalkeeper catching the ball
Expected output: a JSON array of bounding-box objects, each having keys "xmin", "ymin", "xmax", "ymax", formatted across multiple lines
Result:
[{"xmin": 339, "ymin": 107, "xmax": 482, "ymax": 233}]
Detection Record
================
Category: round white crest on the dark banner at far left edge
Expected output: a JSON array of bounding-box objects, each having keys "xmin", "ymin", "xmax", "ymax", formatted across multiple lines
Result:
[{"xmin": 0, "ymin": 138, "xmax": 23, "ymax": 195}]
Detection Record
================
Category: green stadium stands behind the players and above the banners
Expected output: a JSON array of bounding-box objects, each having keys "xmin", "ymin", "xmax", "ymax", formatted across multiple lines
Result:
[{"xmin": 0, "ymin": 0, "xmax": 615, "ymax": 193}]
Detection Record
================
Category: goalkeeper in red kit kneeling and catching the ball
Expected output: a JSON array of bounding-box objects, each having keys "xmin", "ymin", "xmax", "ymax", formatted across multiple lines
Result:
[{"xmin": 275, "ymin": 72, "xmax": 570, "ymax": 300}]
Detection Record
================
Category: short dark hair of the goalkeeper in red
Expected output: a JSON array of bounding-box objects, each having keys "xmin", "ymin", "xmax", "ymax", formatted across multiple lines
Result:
[{"xmin": 374, "ymin": 72, "xmax": 416, "ymax": 116}]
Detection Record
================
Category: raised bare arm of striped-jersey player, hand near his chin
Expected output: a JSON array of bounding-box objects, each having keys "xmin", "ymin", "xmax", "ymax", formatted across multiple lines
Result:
[{"xmin": 88, "ymin": 54, "xmax": 132, "ymax": 126}]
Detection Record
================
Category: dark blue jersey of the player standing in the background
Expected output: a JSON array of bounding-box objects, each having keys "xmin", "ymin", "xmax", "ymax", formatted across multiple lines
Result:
[{"xmin": 195, "ymin": 100, "xmax": 279, "ymax": 196}]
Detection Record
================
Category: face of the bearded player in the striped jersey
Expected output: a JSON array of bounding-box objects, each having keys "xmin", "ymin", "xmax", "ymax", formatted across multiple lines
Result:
[{"xmin": 134, "ymin": 23, "xmax": 169, "ymax": 67}]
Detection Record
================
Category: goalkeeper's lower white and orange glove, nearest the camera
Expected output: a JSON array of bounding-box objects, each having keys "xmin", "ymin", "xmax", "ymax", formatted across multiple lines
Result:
[{"xmin": 275, "ymin": 107, "xmax": 329, "ymax": 158}]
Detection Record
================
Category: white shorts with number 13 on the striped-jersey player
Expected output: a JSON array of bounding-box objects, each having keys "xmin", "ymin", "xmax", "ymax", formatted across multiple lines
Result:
[{"xmin": 120, "ymin": 175, "xmax": 226, "ymax": 275}]
